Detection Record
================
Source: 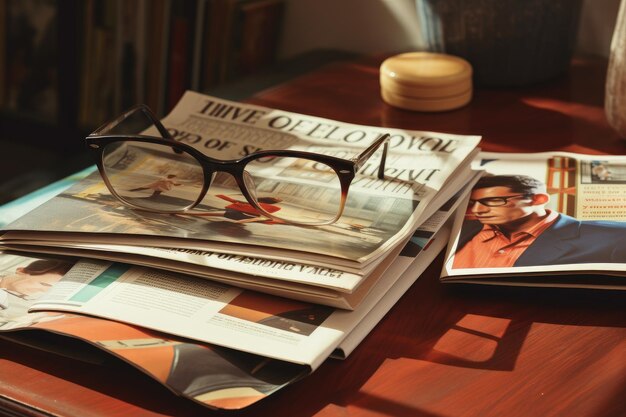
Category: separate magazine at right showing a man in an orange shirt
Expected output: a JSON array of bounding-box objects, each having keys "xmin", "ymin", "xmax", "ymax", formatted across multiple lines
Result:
[{"xmin": 441, "ymin": 152, "xmax": 626, "ymax": 290}]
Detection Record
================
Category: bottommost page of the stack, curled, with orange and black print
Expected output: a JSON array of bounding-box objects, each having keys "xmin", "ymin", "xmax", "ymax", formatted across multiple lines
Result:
[{"xmin": 0, "ymin": 249, "xmax": 304, "ymax": 409}]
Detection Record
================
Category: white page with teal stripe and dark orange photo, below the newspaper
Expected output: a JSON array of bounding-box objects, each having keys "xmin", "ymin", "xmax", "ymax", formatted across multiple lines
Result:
[{"xmin": 32, "ymin": 260, "xmax": 343, "ymax": 368}]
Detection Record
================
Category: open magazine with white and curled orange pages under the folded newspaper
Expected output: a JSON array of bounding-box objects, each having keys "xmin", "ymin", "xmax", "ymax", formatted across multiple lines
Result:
[{"xmin": 0, "ymin": 183, "xmax": 467, "ymax": 409}]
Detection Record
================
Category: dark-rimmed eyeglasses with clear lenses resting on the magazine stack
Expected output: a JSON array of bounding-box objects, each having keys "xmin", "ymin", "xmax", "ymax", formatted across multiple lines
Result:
[{"xmin": 85, "ymin": 105, "xmax": 389, "ymax": 226}]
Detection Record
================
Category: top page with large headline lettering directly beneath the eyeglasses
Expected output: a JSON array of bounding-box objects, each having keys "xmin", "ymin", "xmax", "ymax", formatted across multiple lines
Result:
[{"xmin": 1, "ymin": 92, "xmax": 479, "ymax": 264}]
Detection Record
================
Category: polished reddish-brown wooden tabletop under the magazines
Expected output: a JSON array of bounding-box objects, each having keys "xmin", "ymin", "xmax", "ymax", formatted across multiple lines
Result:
[{"xmin": 0, "ymin": 58, "xmax": 626, "ymax": 417}]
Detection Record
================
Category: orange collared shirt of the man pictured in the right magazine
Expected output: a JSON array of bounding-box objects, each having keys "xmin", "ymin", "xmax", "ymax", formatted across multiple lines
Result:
[{"xmin": 453, "ymin": 210, "xmax": 559, "ymax": 268}]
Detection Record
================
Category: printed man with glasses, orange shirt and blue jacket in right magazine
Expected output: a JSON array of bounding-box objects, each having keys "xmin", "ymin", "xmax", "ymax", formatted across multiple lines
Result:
[{"xmin": 453, "ymin": 175, "xmax": 626, "ymax": 268}]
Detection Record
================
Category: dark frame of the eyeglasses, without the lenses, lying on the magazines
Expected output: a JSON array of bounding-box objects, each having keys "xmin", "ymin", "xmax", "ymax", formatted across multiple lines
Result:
[{"xmin": 85, "ymin": 104, "xmax": 390, "ymax": 226}]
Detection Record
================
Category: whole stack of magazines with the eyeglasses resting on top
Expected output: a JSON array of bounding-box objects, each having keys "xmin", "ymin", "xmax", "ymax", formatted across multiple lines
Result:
[{"xmin": 0, "ymin": 92, "xmax": 480, "ymax": 409}]
